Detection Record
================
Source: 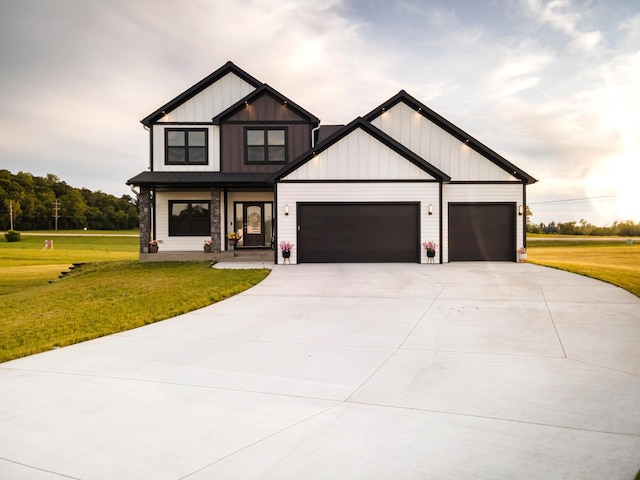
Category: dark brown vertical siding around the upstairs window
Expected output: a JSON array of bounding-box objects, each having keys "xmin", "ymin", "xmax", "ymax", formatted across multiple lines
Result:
[{"xmin": 220, "ymin": 94, "xmax": 313, "ymax": 173}]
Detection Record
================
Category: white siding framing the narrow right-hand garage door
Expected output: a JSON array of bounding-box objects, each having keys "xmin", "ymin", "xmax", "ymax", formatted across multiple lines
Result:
[{"xmin": 442, "ymin": 182, "xmax": 526, "ymax": 262}]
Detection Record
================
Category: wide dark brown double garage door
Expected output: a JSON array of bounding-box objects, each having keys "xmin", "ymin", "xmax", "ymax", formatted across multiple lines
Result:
[{"xmin": 297, "ymin": 203, "xmax": 420, "ymax": 263}]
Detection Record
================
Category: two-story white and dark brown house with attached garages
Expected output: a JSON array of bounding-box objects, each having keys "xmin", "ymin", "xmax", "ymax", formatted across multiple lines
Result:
[{"xmin": 127, "ymin": 62, "xmax": 536, "ymax": 263}]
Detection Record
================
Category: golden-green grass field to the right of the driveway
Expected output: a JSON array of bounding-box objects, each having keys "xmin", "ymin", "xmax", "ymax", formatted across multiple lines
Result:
[{"xmin": 527, "ymin": 237, "xmax": 640, "ymax": 297}]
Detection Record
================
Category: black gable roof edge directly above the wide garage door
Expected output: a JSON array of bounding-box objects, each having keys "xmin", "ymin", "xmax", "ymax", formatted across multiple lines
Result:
[{"xmin": 273, "ymin": 117, "xmax": 451, "ymax": 182}]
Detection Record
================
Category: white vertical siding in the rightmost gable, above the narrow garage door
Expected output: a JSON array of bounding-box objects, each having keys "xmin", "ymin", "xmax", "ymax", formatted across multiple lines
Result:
[{"xmin": 371, "ymin": 102, "xmax": 517, "ymax": 182}]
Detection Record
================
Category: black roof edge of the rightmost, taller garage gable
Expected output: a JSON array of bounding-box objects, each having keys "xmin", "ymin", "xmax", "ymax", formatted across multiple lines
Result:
[{"xmin": 364, "ymin": 90, "xmax": 538, "ymax": 184}]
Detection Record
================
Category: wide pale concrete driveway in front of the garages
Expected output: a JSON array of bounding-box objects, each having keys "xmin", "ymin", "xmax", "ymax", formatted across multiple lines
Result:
[{"xmin": 0, "ymin": 263, "xmax": 640, "ymax": 480}]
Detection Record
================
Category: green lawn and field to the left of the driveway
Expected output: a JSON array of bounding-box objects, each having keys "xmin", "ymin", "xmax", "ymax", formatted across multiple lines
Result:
[{"xmin": 0, "ymin": 235, "xmax": 269, "ymax": 362}]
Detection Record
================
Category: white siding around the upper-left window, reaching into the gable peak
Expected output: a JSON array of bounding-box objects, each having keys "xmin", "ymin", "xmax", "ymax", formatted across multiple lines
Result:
[{"xmin": 153, "ymin": 73, "xmax": 255, "ymax": 172}]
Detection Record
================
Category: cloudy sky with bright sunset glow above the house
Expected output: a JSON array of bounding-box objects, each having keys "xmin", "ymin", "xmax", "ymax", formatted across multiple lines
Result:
[{"xmin": 0, "ymin": 0, "xmax": 640, "ymax": 226}]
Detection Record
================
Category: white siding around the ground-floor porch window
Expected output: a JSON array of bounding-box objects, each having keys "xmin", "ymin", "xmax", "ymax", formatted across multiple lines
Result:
[{"xmin": 155, "ymin": 191, "xmax": 224, "ymax": 252}]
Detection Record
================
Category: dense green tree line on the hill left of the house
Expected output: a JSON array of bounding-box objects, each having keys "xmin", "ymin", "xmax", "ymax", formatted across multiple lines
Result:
[{"xmin": 0, "ymin": 170, "xmax": 138, "ymax": 230}]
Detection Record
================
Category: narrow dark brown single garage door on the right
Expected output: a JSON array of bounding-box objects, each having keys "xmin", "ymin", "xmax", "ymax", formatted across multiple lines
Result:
[{"xmin": 449, "ymin": 203, "xmax": 516, "ymax": 262}]
